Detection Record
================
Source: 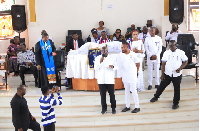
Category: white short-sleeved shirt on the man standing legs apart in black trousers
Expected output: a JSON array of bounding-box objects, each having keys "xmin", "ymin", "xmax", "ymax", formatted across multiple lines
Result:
[{"xmin": 162, "ymin": 49, "xmax": 188, "ymax": 77}]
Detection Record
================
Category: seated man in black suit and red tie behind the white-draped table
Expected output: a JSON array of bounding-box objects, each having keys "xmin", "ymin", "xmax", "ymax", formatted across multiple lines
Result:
[{"xmin": 65, "ymin": 32, "xmax": 85, "ymax": 52}]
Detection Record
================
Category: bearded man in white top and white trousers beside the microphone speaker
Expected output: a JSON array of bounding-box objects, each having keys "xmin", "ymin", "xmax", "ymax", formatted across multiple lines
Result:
[{"xmin": 120, "ymin": 42, "xmax": 140, "ymax": 113}]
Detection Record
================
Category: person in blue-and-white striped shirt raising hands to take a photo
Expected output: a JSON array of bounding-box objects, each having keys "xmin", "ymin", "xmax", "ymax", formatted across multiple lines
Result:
[{"xmin": 39, "ymin": 86, "xmax": 63, "ymax": 131}]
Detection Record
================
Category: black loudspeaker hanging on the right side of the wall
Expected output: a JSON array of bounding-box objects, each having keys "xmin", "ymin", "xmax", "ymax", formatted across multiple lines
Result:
[{"xmin": 169, "ymin": 0, "xmax": 184, "ymax": 25}]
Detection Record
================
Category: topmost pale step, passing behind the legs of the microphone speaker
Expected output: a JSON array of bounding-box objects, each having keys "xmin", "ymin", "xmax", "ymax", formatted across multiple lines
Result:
[{"xmin": 0, "ymin": 87, "xmax": 199, "ymax": 105}]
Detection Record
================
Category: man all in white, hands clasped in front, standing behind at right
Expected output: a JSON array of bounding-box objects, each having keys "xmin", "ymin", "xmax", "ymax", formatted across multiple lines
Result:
[{"xmin": 144, "ymin": 27, "xmax": 163, "ymax": 90}]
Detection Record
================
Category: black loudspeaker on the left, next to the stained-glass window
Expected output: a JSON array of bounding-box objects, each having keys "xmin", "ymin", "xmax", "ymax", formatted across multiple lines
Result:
[{"xmin": 11, "ymin": 5, "xmax": 27, "ymax": 31}]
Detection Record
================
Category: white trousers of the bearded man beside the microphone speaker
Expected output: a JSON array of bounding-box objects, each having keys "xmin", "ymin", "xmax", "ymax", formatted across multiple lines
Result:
[{"xmin": 124, "ymin": 82, "xmax": 140, "ymax": 108}]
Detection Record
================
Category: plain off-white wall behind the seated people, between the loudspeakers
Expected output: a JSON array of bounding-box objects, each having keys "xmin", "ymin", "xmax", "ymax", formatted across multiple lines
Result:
[{"xmin": 29, "ymin": 0, "xmax": 163, "ymax": 47}]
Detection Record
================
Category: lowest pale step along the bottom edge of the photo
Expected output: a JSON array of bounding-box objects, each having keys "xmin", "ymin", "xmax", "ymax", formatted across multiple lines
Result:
[{"xmin": 0, "ymin": 116, "xmax": 199, "ymax": 131}]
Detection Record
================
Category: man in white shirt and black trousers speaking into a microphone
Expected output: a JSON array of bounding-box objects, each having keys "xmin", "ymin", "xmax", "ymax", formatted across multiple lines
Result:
[{"xmin": 94, "ymin": 46, "xmax": 117, "ymax": 114}]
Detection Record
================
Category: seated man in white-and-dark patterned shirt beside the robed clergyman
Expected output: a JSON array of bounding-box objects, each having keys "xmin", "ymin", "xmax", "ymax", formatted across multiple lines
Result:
[{"xmin": 17, "ymin": 44, "xmax": 38, "ymax": 87}]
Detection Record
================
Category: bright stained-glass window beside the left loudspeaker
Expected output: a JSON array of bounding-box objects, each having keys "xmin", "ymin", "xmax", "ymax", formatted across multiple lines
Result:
[{"xmin": 0, "ymin": 0, "xmax": 15, "ymax": 37}]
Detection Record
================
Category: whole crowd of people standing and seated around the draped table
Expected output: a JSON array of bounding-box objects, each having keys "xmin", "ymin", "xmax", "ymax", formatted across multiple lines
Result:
[{"xmin": 8, "ymin": 20, "xmax": 188, "ymax": 131}]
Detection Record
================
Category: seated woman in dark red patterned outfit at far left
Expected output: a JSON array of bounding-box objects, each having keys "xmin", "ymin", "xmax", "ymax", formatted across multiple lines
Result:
[{"xmin": 7, "ymin": 36, "xmax": 20, "ymax": 76}]
